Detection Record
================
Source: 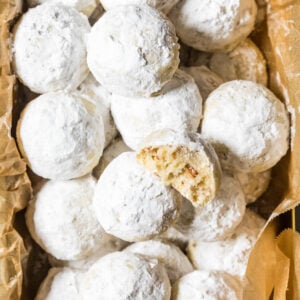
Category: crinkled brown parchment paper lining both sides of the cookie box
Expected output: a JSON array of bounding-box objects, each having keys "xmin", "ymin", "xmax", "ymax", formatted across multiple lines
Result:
[{"xmin": 0, "ymin": 0, "xmax": 300, "ymax": 300}]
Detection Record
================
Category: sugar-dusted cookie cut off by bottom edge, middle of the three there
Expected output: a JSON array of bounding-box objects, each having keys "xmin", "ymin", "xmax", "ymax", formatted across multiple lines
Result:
[{"xmin": 81, "ymin": 252, "xmax": 171, "ymax": 300}]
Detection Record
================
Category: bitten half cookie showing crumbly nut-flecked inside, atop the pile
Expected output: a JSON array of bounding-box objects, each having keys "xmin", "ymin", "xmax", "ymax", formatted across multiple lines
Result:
[{"xmin": 137, "ymin": 129, "xmax": 222, "ymax": 207}]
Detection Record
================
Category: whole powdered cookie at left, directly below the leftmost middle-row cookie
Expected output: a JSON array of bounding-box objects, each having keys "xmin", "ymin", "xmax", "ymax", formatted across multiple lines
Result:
[{"xmin": 26, "ymin": 176, "xmax": 110, "ymax": 260}]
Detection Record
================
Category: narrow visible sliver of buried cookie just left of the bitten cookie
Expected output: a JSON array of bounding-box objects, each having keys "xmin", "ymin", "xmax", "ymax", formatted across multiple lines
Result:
[{"xmin": 93, "ymin": 137, "xmax": 130, "ymax": 178}]
